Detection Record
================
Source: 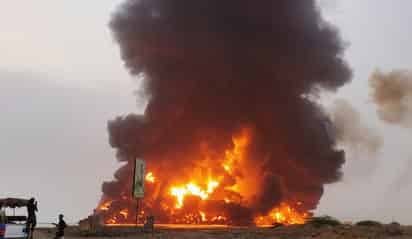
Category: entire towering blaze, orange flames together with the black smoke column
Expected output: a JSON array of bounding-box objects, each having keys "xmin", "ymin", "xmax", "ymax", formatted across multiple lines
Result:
[{"xmin": 95, "ymin": 0, "xmax": 351, "ymax": 225}]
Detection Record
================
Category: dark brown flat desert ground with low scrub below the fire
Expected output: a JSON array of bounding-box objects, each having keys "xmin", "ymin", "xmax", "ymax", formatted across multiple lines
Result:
[{"xmin": 35, "ymin": 223, "xmax": 412, "ymax": 239}]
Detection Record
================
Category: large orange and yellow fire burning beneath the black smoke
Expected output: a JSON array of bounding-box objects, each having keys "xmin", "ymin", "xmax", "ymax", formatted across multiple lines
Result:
[{"xmin": 97, "ymin": 129, "xmax": 310, "ymax": 226}]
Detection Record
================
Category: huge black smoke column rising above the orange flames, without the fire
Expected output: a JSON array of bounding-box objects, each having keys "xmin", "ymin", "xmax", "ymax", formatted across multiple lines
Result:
[{"xmin": 103, "ymin": 0, "xmax": 351, "ymax": 223}]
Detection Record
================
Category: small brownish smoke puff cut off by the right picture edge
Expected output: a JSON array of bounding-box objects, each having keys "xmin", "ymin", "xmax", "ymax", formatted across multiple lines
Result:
[{"xmin": 369, "ymin": 70, "xmax": 412, "ymax": 127}]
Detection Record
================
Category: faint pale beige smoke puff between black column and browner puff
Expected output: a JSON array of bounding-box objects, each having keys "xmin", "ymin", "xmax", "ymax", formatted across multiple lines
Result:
[{"xmin": 330, "ymin": 99, "xmax": 383, "ymax": 156}]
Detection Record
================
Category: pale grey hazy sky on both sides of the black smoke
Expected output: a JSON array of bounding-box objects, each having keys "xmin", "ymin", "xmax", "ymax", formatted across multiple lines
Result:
[{"xmin": 0, "ymin": 0, "xmax": 412, "ymax": 224}]
